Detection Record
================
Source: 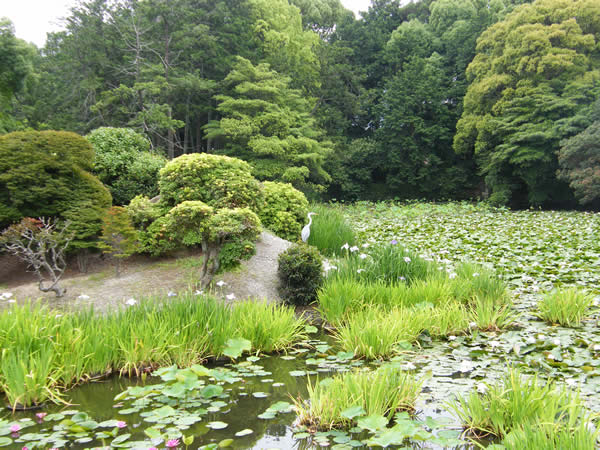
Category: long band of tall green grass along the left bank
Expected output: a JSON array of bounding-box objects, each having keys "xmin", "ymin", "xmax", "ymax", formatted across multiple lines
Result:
[{"xmin": 0, "ymin": 294, "xmax": 305, "ymax": 406}]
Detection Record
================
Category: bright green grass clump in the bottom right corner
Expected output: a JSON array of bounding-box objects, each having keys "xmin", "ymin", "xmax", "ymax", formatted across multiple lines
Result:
[{"xmin": 447, "ymin": 369, "xmax": 590, "ymax": 442}]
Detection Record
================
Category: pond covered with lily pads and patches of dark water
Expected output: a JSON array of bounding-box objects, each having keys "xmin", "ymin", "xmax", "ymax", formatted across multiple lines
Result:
[{"xmin": 0, "ymin": 205, "xmax": 600, "ymax": 449}]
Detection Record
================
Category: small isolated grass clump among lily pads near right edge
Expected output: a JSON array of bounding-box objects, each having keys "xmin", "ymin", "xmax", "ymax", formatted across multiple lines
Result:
[{"xmin": 537, "ymin": 288, "xmax": 594, "ymax": 327}]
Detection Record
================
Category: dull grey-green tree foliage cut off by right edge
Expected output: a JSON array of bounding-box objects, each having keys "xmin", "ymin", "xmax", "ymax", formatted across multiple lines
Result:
[{"xmin": 558, "ymin": 121, "xmax": 600, "ymax": 205}]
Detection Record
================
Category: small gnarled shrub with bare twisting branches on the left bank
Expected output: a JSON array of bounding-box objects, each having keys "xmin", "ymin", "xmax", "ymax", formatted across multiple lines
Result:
[{"xmin": 0, "ymin": 217, "xmax": 73, "ymax": 297}]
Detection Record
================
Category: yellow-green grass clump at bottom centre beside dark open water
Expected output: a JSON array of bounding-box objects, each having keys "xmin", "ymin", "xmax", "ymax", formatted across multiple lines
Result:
[{"xmin": 296, "ymin": 365, "xmax": 421, "ymax": 429}]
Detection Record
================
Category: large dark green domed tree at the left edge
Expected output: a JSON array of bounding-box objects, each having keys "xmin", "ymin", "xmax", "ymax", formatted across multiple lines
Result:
[{"xmin": 0, "ymin": 131, "xmax": 111, "ymax": 248}]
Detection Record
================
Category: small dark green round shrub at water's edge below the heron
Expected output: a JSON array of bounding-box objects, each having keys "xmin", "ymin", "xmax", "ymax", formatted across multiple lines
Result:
[{"xmin": 277, "ymin": 244, "xmax": 323, "ymax": 305}]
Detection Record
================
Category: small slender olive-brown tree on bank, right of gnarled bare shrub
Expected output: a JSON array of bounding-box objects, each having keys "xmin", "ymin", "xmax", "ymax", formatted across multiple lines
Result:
[{"xmin": 98, "ymin": 206, "xmax": 138, "ymax": 277}]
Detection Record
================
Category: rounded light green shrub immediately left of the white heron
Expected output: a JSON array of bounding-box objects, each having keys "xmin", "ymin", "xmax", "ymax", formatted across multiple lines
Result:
[{"xmin": 258, "ymin": 181, "xmax": 308, "ymax": 241}]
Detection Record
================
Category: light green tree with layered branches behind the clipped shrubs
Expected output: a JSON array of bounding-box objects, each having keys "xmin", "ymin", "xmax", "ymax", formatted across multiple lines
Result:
[{"xmin": 207, "ymin": 57, "xmax": 331, "ymax": 190}]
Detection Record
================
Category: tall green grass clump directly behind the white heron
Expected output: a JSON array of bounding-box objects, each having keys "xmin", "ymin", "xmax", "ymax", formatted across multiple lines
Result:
[{"xmin": 308, "ymin": 204, "xmax": 356, "ymax": 256}]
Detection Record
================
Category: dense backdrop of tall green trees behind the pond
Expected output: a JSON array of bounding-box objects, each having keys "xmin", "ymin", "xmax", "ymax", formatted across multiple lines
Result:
[{"xmin": 0, "ymin": 0, "xmax": 600, "ymax": 207}]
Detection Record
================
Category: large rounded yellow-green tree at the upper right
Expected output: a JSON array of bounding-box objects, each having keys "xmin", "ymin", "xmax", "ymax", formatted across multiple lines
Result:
[{"xmin": 454, "ymin": 0, "xmax": 600, "ymax": 205}]
